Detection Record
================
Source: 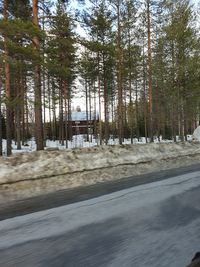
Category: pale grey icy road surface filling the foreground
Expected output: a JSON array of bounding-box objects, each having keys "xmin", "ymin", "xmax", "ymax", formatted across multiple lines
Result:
[{"xmin": 0, "ymin": 171, "xmax": 200, "ymax": 267}]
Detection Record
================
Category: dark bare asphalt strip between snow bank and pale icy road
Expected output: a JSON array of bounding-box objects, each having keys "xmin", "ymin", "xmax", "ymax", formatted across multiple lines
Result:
[{"xmin": 0, "ymin": 164, "xmax": 200, "ymax": 221}]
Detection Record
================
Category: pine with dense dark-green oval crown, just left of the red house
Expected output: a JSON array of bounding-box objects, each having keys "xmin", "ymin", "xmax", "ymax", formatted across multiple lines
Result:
[{"xmin": 47, "ymin": 1, "xmax": 75, "ymax": 146}]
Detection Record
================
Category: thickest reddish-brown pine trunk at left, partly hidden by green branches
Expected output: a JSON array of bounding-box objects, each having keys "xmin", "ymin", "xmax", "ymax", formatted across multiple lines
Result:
[{"xmin": 32, "ymin": 0, "xmax": 44, "ymax": 150}]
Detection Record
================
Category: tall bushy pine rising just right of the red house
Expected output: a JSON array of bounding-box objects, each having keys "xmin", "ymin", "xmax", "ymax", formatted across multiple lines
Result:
[{"xmin": 83, "ymin": 1, "xmax": 115, "ymax": 144}]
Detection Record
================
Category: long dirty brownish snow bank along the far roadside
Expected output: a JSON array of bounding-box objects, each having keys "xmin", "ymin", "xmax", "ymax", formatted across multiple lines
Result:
[{"xmin": 0, "ymin": 142, "xmax": 200, "ymax": 202}]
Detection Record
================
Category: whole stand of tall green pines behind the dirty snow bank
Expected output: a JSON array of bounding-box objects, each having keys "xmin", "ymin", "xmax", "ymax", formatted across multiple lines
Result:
[{"xmin": 0, "ymin": 0, "xmax": 200, "ymax": 156}]
